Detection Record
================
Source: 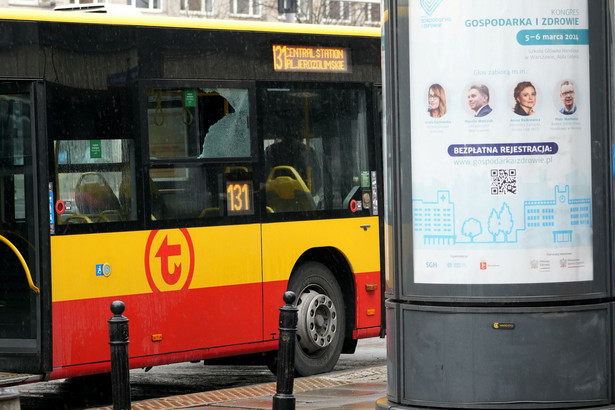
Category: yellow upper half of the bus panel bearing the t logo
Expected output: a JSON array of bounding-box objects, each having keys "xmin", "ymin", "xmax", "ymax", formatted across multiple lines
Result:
[{"xmin": 51, "ymin": 224, "xmax": 261, "ymax": 302}]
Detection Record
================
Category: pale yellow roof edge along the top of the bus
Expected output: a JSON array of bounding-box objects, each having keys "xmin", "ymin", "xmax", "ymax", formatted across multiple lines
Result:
[{"xmin": 0, "ymin": 9, "xmax": 380, "ymax": 37}]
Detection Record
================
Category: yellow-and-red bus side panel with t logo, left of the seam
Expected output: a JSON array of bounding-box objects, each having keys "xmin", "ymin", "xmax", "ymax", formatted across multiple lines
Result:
[{"xmin": 47, "ymin": 225, "xmax": 263, "ymax": 376}]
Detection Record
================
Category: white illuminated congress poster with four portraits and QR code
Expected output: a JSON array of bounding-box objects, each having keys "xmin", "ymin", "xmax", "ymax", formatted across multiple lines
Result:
[{"xmin": 412, "ymin": 0, "xmax": 593, "ymax": 284}]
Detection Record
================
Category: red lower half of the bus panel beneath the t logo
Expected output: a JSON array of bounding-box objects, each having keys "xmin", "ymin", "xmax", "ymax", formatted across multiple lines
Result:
[{"xmin": 52, "ymin": 283, "xmax": 262, "ymax": 376}]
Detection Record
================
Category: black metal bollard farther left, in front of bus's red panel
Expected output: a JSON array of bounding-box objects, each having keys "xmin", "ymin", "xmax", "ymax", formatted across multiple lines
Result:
[{"xmin": 107, "ymin": 300, "xmax": 130, "ymax": 410}]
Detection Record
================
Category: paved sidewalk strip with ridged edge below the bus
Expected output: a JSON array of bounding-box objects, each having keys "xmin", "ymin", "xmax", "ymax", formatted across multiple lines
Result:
[{"xmin": 89, "ymin": 366, "xmax": 387, "ymax": 410}]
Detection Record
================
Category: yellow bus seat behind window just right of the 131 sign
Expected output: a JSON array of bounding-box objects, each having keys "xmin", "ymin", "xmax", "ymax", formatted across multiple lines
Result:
[{"xmin": 266, "ymin": 165, "xmax": 316, "ymax": 212}]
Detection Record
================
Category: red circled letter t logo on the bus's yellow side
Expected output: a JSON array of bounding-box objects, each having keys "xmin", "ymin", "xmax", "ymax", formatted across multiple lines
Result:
[{"xmin": 145, "ymin": 229, "xmax": 194, "ymax": 292}]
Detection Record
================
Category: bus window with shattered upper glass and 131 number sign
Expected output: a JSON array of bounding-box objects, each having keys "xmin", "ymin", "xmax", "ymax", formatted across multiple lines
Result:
[{"xmin": 148, "ymin": 88, "xmax": 254, "ymax": 220}]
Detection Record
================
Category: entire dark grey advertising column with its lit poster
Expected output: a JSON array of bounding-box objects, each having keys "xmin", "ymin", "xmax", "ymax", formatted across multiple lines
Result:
[{"xmin": 378, "ymin": 0, "xmax": 613, "ymax": 409}]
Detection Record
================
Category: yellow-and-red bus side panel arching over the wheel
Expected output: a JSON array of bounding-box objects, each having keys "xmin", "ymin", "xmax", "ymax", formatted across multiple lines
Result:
[{"xmin": 263, "ymin": 217, "xmax": 380, "ymax": 337}]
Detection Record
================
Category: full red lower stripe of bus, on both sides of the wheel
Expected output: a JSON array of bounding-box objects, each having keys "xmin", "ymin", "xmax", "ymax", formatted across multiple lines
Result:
[{"xmin": 51, "ymin": 272, "xmax": 380, "ymax": 379}]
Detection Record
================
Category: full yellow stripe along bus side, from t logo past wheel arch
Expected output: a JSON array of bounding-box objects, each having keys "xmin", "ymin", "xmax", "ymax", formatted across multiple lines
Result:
[{"xmin": 51, "ymin": 217, "xmax": 380, "ymax": 302}]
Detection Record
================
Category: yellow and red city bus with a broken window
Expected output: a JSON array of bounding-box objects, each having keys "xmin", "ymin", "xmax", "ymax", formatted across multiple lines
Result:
[{"xmin": 0, "ymin": 11, "xmax": 383, "ymax": 384}]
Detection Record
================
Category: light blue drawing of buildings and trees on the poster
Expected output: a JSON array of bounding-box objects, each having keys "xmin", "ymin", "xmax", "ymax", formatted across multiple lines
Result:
[{"xmin": 413, "ymin": 185, "xmax": 592, "ymax": 246}]
